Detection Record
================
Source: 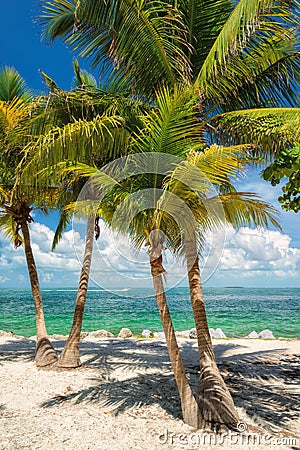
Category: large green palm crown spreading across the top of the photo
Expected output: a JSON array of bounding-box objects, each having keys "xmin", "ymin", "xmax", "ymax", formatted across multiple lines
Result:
[{"xmin": 39, "ymin": 0, "xmax": 300, "ymax": 218}]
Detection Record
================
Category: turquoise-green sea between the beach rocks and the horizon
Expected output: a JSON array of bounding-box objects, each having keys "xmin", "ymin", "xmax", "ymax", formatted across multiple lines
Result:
[{"xmin": 0, "ymin": 287, "xmax": 300, "ymax": 338}]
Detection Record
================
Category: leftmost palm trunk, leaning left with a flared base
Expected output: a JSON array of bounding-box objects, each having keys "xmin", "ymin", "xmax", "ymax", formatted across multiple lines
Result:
[{"xmin": 20, "ymin": 220, "xmax": 57, "ymax": 367}]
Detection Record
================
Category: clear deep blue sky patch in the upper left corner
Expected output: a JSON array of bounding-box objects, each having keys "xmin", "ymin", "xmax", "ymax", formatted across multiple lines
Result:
[{"xmin": 0, "ymin": 0, "xmax": 91, "ymax": 91}]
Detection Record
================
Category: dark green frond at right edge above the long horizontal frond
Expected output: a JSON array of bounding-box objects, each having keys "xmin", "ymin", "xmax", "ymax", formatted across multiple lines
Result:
[{"xmin": 211, "ymin": 50, "xmax": 300, "ymax": 111}]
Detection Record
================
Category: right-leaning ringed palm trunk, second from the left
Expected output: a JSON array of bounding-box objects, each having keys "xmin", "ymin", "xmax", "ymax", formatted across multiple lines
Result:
[{"xmin": 57, "ymin": 215, "xmax": 95, "ymax": 368}]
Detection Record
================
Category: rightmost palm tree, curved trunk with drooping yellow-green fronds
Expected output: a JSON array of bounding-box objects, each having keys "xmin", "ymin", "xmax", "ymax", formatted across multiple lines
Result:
[{"xmin": 163, "ymin": 146, "xmax": 279, "ymax": 425}]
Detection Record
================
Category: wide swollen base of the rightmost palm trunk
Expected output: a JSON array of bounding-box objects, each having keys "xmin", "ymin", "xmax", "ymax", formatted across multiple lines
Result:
[{"xmin": 196, "ymin": 365, "xmax": 240, "ymax": 429}]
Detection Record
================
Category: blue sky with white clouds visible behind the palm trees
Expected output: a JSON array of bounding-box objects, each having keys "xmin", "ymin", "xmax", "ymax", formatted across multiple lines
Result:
[{"xmin": 0, "ymin": 0, "xmax": 300, "ymax": 289}]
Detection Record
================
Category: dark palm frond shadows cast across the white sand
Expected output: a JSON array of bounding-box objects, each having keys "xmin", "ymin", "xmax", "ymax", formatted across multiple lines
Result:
[{"xmin": 0, "ymin": 339, "xmax": 300, "ymax": 432}]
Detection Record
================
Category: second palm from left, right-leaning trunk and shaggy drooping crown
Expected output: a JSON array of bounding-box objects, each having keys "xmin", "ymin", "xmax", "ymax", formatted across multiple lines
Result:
[{"xmin": 24, "ymin": 67, "xmax": 144, "ymax": 368}]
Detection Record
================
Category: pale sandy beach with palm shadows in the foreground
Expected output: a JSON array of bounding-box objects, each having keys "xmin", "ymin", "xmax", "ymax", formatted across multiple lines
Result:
[{"xmin": 0, "ymin": 336, "xmax": 300, "ymax": 450}]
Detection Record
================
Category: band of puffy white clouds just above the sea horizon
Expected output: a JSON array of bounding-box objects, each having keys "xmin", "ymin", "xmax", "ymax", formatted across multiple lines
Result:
[{"xmin": 0, "ymin": 218, "xmax": 300, "ymax": 289}]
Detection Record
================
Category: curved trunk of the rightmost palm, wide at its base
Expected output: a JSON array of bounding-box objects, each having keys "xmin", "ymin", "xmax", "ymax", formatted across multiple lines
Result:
[{"xmin": 186, "ymin": 236, "xmax": 239, "ymax": 427}]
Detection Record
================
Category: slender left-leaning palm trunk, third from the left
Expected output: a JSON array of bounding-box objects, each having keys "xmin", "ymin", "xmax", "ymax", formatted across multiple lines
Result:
[{"xmin": 151, "ymin": 265, "xmax": 199, "ymax": 429}]
